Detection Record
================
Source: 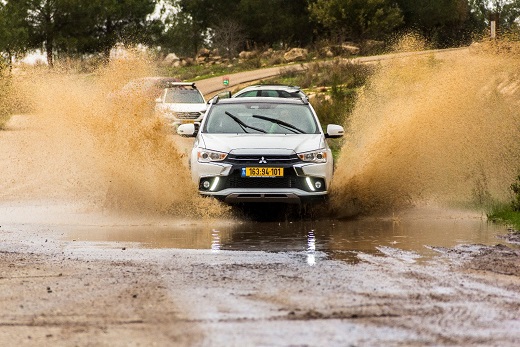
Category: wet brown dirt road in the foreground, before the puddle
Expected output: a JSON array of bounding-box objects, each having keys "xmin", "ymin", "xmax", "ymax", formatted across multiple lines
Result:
[{"xmin": 0, "ymin": 204, "xmax": 520, "ymax": 346}]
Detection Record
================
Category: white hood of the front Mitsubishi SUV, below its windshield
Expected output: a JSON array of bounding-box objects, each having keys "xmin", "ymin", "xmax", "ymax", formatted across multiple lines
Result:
[{"xmin": 199, "ymin": 134, "xmax": 325, "ymax": 155}]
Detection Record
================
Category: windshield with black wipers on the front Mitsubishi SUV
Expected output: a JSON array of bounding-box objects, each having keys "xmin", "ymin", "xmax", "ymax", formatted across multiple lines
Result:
[{"xmin": 203, "ymin": 103, "xmax": 319, "ymax": 134}]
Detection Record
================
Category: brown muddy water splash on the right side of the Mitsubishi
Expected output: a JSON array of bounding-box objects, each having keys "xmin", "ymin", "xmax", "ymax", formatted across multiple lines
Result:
[{"xmin": 332, "ymin": 42, "xmax": 520, "ymax": 216}]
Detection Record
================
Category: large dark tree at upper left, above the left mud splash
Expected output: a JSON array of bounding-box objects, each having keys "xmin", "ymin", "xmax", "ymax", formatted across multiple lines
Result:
[{"xmin": 22, "ymin": 0, "xmax": 162, "ymax": 66}]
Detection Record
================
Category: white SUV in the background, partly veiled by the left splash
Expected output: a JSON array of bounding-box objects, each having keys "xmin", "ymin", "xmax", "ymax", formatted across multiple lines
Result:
[{"xmin": 155, "ymin": 82, "xmax": 207, "ymax": 127}]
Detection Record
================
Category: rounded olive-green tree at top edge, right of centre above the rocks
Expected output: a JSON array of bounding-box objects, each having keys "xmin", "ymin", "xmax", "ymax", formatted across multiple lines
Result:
[{"xmin": 309, "ymin": 0, "xmax": 403, "ymax": 40}]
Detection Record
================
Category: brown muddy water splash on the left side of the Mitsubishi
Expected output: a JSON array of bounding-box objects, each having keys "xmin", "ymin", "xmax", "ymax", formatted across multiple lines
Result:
[{"xmin": 5, "ymin": 54, "xmax": 225, "ymax": 217}]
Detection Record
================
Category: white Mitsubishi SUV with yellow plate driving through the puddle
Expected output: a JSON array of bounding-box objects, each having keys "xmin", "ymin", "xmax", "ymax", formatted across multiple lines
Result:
[{"xmin": 177, "ymin": 97, "xmax": 344, "ymax": 204}]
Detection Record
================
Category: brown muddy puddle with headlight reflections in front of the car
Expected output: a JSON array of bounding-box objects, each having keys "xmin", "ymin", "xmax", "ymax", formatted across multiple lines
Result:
[{"xmin": 66, "ymin": 211, "xmax": 507, "ymax": 266}]
